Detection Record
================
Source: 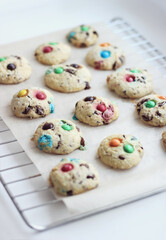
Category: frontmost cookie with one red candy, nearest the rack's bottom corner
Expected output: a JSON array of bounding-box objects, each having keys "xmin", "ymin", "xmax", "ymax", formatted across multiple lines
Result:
[{"xmin": 50, "ymin": 158, "xmax": 99, "ymax": 196}]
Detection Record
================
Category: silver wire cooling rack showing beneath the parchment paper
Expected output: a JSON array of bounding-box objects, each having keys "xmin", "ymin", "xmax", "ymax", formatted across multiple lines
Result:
[{"xmin": 0, "ymin": 18, "xmax": 166, "ymax": 231}]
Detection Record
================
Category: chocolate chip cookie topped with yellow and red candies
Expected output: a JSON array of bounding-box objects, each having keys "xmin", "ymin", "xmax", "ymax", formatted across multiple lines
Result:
[{"xmin": 11, "ymin": 87, "xmax": 54, "ymax": 119}]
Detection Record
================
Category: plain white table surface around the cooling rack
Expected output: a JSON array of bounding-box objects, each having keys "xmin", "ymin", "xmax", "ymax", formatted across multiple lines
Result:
[{"xmin": 0, "ymin": 0, "xmax": 166, "ymax": 240}]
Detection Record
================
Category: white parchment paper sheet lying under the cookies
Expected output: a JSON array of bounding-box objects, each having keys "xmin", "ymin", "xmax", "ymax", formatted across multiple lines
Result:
[{"xmin": 0, "ymin": 23, "xmax": 166, "ymax": 213}]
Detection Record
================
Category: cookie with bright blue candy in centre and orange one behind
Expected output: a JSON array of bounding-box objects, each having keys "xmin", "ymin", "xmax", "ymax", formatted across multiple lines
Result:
[{"xmin": 86, "ymin": 43, "xmax": 125, "ymax": 70}]
